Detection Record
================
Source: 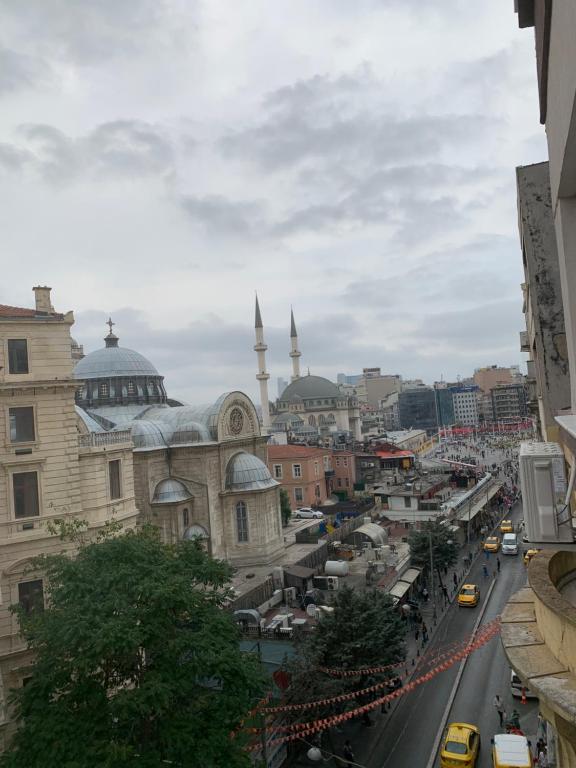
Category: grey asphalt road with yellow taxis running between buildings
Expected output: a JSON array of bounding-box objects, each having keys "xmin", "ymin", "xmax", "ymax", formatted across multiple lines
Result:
[{"xmin": 366, "ymin": 498, "xmax": 537, "ymax": 768}]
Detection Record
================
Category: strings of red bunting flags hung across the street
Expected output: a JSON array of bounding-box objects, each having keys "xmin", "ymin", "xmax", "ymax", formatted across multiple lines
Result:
[{"xmin": 244, "ymin": 619, "xmax": 500, "ymax": 751}]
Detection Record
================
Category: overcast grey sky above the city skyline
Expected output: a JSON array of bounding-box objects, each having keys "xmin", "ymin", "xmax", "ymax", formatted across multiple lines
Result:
[{"xmin": 0, "ymin": 0, "xmax": 547, "ymax": 403}]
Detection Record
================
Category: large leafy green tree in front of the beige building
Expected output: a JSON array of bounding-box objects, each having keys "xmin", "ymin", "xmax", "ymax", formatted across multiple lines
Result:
[{"xmin": 0, "ymin": 527, "xmax": 262, "ymax": 768}]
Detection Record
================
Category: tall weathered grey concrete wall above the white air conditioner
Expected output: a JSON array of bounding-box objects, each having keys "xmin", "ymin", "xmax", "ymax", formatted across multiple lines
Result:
[{"xmin": 516, "ymin": 163, "xmax": 570, "ymax": 441}]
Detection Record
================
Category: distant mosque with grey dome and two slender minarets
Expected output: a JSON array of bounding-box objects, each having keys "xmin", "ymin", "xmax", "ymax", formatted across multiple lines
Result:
[{"xmin": 254, "ymin": 298, "xmax": 362, "ymax": 440}]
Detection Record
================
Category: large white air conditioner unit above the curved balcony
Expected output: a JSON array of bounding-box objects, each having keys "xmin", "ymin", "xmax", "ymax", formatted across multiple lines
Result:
[{"xmin": 519, "ymin": 442, "xmax": 574, "ymax": 543}]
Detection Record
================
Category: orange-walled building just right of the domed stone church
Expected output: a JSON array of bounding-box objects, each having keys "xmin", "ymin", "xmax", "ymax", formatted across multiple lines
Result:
[{"xmin": 267, "ymin": 445, "xmax": 330, "ymax": 509}]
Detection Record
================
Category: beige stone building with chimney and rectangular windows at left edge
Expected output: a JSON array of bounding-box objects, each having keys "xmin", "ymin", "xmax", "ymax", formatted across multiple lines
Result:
[{"xmin": 0, "ymin": 287, "xmax": 137, "ymax": 747}]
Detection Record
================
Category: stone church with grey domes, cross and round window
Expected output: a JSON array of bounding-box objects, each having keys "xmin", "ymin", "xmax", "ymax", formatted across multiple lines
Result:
[{"xmin": 74, "ymin": 322, "xmax": 284, "ymax": 565}]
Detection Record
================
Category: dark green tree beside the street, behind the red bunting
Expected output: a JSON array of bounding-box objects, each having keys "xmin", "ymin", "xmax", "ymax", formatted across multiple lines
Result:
[{"xmin": 289, "ymin": 585, "xmax": 405, "ymax": 720}]
